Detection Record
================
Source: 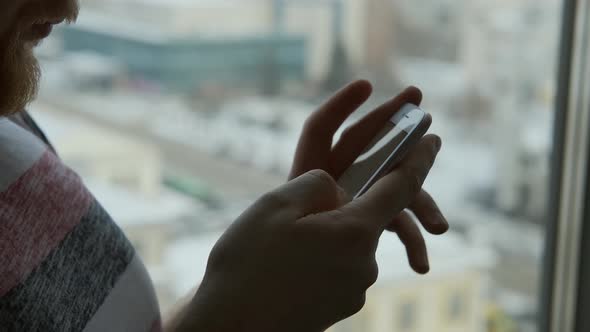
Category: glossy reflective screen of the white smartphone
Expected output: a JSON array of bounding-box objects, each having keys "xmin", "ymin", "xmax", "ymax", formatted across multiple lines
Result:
[{"xmin": 338, "ymin": 107, "xmax": 425, "ymax": 198}]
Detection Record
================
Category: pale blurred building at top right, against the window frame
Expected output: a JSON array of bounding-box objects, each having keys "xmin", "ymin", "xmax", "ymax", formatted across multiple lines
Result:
[{"xmin": 460, "ymin": 0, "xmax": 561, "ymax": 102}]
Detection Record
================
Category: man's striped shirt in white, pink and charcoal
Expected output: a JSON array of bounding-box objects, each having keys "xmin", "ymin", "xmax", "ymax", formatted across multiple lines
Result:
[{"xmin": 0, "ymin": 118, "xmax": 159, "ymax": 331}]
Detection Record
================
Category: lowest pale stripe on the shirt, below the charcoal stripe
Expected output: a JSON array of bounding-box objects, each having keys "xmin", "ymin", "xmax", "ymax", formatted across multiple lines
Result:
[{"xmin": 84, "ymin": 255, "xmax": 160, "ymax": 332}]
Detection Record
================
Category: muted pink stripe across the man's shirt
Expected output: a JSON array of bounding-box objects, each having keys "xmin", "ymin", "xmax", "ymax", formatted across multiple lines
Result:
[{"xmin": 0, "ymin": 151, "xmax": 92, "ymax": 297}]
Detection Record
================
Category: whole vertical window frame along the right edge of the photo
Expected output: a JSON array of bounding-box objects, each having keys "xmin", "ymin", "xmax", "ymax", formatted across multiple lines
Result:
[{"xmin": 538, "ymin": 0, "xmax": 590, "ymax": 332}]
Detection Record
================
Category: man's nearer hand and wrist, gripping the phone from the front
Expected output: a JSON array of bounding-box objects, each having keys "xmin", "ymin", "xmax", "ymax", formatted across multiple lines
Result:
[{"xmin": 180, "ymin": 135, "xmax": 440, "ymax": 332}]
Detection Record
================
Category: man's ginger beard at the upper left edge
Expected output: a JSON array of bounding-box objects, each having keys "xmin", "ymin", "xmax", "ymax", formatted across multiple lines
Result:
[{"xmin": 0, "ymin": 27, "xmax": 41, "ymax": 116}]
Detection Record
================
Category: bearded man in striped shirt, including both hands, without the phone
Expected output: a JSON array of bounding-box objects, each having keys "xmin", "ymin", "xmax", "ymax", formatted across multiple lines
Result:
[{"xmin": 0, "ymin": 0, "xmax": 448, "ymax": 332}]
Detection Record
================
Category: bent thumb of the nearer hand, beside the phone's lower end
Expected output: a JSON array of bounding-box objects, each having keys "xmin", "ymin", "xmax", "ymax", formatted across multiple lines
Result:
[{"xmin": 262, "ymin": 169, "xmax": 349, "ymax": 219}]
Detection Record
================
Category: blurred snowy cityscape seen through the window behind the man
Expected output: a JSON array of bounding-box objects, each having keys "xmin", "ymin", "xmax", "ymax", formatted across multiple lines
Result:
[{"xmin": 31, "ymin": 0, "xmax": 561, "ymax": 332}]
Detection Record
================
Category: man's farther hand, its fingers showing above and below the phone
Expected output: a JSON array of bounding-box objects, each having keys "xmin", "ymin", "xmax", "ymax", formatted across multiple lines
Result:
[{"xmin": 289, "ymin": 81, "xmax": 449, "ymax": 273}]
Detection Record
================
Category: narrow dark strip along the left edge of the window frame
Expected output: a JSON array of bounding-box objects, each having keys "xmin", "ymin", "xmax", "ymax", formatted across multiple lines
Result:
[{"xmin": 537, "ymin": 0, "xmax": 577, "ymax": 332}]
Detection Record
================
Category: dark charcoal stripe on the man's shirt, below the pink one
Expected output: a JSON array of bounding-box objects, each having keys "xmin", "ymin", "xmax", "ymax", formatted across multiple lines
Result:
[{"xmin": 0, "ymin": 202, "xmax": 134, "ymax": 332}]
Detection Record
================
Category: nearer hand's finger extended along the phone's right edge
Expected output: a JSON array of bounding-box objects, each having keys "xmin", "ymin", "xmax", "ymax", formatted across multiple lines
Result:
[{"xmin": 349, "ymin": 135, "xmax": 442, "ymax": 229}]
